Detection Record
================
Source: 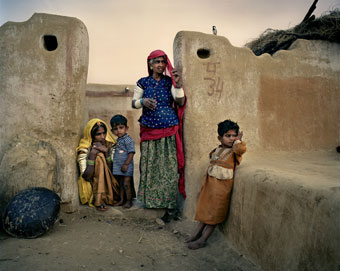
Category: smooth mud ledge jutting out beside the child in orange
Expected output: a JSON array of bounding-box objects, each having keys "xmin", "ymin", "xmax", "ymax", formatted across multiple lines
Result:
[{"xmin": 224, "ymin": 151, "xmax": 340, "ymax": 270}]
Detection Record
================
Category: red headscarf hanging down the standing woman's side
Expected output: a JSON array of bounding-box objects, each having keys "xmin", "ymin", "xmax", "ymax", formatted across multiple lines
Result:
[{"xmin": 143, "ymin": 50, "xmax": 187, "ymax": 198}]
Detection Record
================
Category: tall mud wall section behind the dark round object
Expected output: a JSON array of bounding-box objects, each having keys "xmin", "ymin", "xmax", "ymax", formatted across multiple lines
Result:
[{"xmin": 0, "ymin": 14, "xmax": 89, "ymax": 214}]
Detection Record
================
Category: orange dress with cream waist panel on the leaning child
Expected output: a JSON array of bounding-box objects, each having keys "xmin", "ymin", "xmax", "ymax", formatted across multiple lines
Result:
[{"xmin": 195, "ymin": 140, "xmax": 246, "ymax": 225}]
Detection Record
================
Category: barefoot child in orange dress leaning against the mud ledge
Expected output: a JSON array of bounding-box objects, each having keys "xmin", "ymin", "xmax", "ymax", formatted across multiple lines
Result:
[{"xmin": 186, "ymin": 120, "xmax": 246, "ymax": 249}]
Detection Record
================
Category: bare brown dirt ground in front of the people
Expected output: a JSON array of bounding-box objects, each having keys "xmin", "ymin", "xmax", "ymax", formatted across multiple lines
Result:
[{"xmin": 0, "ymin": 206, "xmax": 259, "ymax": 271}]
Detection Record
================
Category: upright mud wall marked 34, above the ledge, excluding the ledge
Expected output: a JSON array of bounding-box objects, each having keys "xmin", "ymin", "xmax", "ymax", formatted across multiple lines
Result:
[{"xmin": 174, "ymin": 32, "xmax": 340, "ymax": 221}]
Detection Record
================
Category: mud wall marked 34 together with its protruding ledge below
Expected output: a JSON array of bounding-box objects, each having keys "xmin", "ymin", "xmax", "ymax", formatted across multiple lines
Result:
[{"xmin": 174, "ymin": 32, "xmax": 340, "ymax": 270}]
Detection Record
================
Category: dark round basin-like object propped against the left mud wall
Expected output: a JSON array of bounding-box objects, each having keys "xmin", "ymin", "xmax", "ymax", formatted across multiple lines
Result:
[{"xmin": 2, "ymin": 187, "xmax": 60, "ymax": 238}]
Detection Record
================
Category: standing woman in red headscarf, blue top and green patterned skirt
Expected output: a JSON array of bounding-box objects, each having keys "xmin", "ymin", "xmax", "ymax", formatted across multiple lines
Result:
[{"xmin": 132, "ymin": 50, "xmax": 186, "ymax": 221}]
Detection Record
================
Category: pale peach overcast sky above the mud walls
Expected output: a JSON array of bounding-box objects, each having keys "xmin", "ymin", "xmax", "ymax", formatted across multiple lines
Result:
[{"xmin": 0, "ymin": 0, "xmax": 340, "ymax": 84}]
